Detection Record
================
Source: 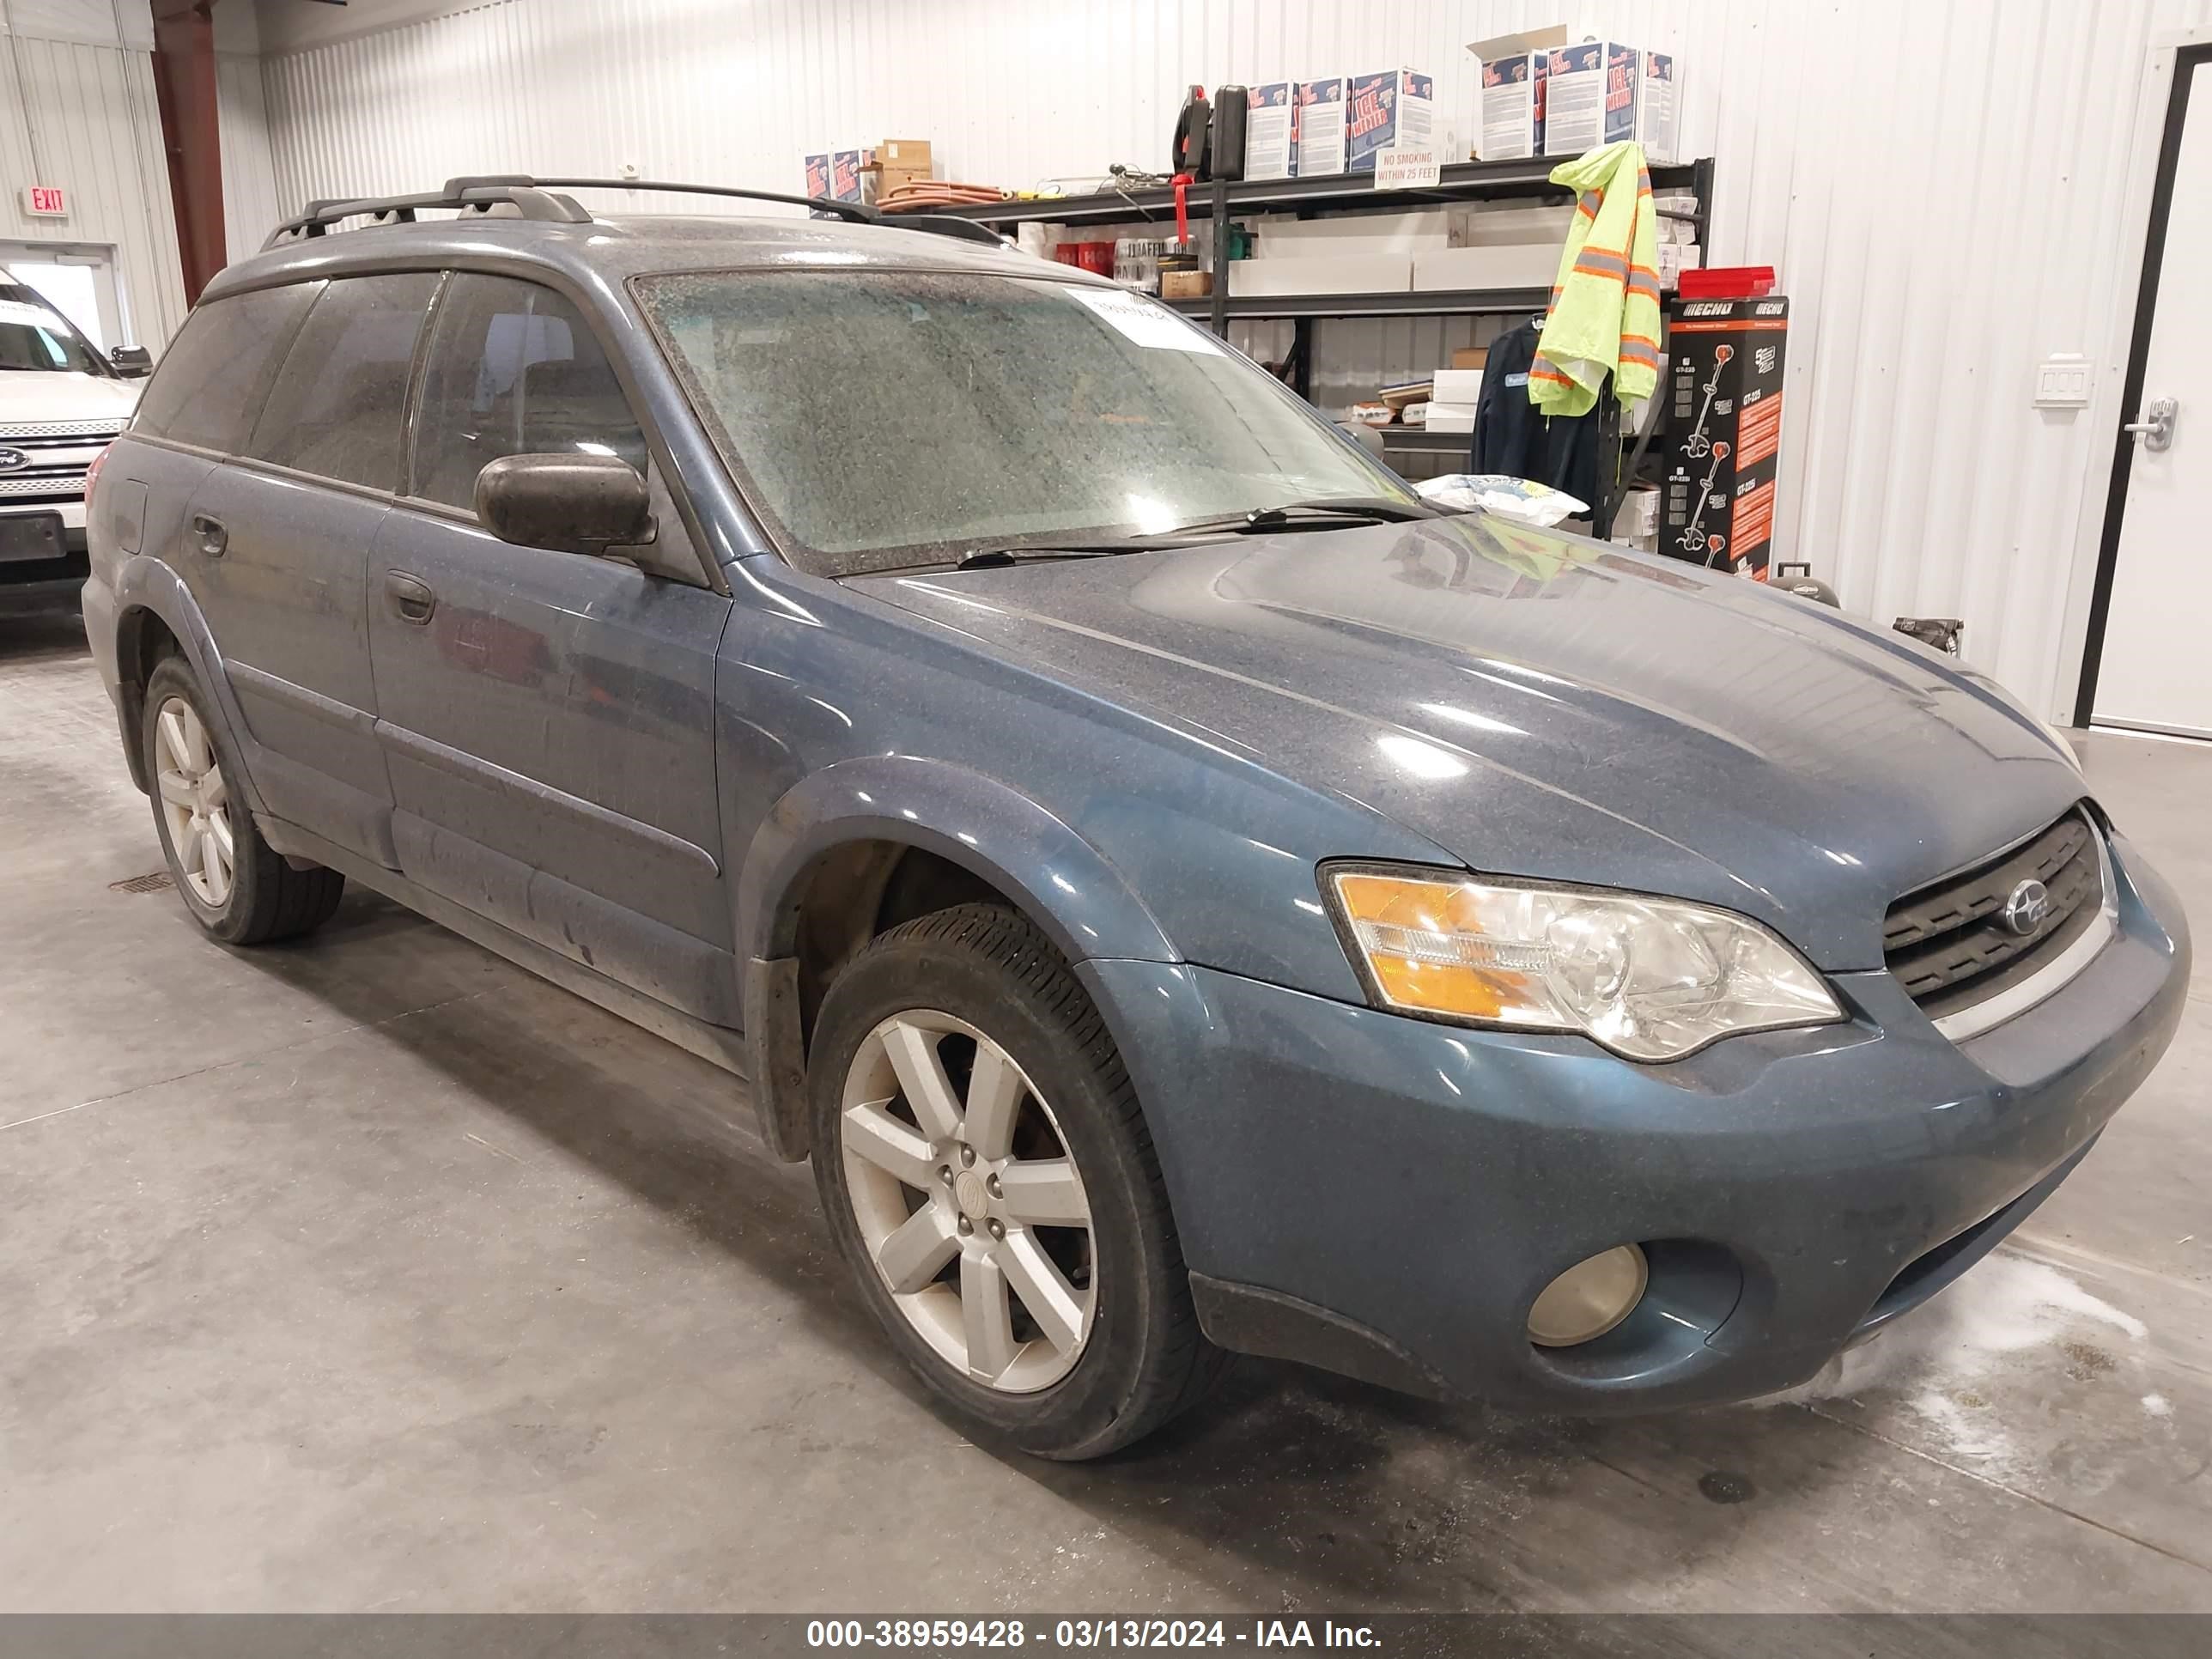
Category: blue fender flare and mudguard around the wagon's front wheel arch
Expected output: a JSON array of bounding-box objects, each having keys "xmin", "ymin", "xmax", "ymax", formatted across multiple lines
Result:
[{"xmin": 737, "ymin": 754, "xmax": 1183, "ymax": 1159}]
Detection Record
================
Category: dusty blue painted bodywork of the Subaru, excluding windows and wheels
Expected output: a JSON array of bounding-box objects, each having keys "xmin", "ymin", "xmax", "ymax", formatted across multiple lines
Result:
[{"xmin": 86, "ymin": 222, "xmax": 2188, "ymax": 1409}]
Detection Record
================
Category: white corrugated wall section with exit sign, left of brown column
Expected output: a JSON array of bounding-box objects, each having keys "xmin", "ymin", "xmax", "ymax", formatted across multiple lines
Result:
[{"xmin": 0, "ymin": 0, "xmax": 184, "ymax": 349}]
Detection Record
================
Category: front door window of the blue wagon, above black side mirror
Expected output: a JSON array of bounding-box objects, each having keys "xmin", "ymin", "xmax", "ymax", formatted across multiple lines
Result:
[{"xmin": 414, "ymin": 272, "xmax": 646, "ymax": 507}]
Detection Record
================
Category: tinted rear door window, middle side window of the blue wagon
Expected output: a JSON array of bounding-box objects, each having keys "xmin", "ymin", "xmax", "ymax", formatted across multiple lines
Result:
[{"xmin": 246, "ymin": 270, "xmax": 438, "ymax": 489}]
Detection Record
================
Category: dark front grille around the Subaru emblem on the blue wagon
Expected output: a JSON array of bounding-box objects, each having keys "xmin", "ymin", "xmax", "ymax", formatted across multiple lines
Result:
[{"xmin": 1882, "ymin": 807, "xmax": 2104, "ymax": 1020}]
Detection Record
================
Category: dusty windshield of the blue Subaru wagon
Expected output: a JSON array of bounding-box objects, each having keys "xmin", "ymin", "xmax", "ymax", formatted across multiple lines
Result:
[{"xmin": 637, "ymin": 270, "xmax": 1418, "ymax": 575}]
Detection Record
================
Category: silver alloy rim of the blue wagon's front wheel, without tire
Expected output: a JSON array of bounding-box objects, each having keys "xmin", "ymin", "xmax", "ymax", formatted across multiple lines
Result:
[{"xmin": 841, "ymin": 1009, "xmax": 1097, "ymax": 1394}]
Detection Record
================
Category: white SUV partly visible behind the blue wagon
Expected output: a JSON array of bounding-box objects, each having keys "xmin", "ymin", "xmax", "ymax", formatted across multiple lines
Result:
[{"xmin": 0, "ymin": 283, "xmax": 143, "ymax": 608}]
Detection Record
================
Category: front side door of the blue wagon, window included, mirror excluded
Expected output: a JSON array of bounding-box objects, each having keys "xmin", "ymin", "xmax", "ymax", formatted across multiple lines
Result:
[{"xmin": 369, "ymin": 272, "xmax": 738, "ymax": 1026}]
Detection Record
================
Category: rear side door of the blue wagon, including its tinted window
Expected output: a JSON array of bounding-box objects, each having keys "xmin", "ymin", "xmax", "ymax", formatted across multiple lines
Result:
[{"xmin": 184, "ymin": 272, "xmax": 441, "ymax": 865}]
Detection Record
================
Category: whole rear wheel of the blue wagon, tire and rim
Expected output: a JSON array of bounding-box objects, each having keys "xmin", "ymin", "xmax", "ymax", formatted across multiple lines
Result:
[{"xmin": 139, "ymin": 657, "xmax": 345, "ymax": 945}]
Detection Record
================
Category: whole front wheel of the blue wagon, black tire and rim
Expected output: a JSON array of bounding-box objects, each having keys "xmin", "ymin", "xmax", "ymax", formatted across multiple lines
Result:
[{"xmin": 807, "ymin": 905, "xmax": 1225, "ymax": 1460}]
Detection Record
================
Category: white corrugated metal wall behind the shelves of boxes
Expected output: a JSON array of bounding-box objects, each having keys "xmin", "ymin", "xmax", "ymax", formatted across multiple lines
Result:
[{"xmin": 242, "ymin": 0, "xmax": 2212, "ymax": 710}]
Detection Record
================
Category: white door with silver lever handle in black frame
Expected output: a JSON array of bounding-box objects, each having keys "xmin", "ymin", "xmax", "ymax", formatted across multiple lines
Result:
[{"xmin": 2093, "ymin": 46, "xmax": 2212, "ymax": 737}]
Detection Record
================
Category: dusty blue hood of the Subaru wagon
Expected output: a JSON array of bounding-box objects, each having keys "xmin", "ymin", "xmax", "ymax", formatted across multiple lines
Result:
[{"xmin": 858, "ymin": 515, "xmax": 2084, "ymax": 969}]
